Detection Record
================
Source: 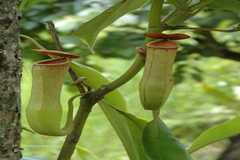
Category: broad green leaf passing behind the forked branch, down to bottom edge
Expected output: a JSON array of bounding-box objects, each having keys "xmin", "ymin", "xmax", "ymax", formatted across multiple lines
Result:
[{"xmin": 71, "ymin": 63, "xmax": 152, "ymax": 160}]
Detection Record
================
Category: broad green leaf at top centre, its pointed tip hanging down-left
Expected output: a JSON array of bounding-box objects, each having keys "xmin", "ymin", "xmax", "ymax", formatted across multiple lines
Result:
[{"xmin": 75, "ymin": 0, "xmax": 148, "ymax": 48}]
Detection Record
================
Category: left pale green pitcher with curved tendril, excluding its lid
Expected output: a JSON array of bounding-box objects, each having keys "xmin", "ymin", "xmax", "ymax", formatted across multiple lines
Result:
[{"xmin": 26, "ymin": 58, "xmax": 74, "ymax": 136}]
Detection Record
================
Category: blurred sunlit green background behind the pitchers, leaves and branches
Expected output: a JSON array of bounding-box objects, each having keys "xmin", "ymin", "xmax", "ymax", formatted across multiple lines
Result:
[{"xmin": 20, "ymin": 0, "xmax": 240, "ymax": 160}]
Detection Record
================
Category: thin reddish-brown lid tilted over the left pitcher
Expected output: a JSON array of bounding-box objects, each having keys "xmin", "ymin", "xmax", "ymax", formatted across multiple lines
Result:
[{"xmin": 33, "ymin": 49, "xmax": 79, "ymax": 58}]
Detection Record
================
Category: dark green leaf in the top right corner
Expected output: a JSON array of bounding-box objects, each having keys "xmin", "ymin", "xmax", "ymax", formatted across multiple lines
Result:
[{"xmin": 208, "ymin": 0, "xmax": 240, "ymax": 14}]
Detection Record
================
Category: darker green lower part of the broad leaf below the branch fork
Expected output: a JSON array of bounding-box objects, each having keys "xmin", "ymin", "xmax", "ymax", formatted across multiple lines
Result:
[{"xmin": 99, "ymin": 101, "xmax": 150, "ymax": 160}]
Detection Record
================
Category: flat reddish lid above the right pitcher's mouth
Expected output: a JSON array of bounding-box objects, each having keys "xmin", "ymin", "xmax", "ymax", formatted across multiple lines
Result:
[{"xmin": 145, "ymin": 33, "xmax": 190, "ymax": 40}]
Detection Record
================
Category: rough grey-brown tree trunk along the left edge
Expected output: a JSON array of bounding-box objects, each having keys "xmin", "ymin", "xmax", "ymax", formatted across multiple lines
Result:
[{"xmin": 0, "ymin": 0, "xmax": 21, "ymax": 160}]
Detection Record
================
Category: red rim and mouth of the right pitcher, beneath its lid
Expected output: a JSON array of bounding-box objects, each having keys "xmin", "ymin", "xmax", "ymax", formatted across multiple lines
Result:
[{"xmin": 146, "ymin": 41, "xmax": 178, "ymax": 49}]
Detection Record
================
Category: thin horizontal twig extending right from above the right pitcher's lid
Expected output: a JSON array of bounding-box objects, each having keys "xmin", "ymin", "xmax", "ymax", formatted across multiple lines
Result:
[{"xmin": 164, "ymin": 24, "xmax": 240, "ymax": 32}]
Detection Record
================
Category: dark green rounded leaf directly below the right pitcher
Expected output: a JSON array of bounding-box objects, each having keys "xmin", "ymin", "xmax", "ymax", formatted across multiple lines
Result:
[{"xmin": 143, "ymin": 119, "xmax": 192, "ymax": 160}]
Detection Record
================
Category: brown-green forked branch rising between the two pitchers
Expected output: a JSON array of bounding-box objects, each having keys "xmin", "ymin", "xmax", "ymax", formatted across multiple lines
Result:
[{"xmin": 45, "ymin": 22, "xmax": 145, "ymax": 160}]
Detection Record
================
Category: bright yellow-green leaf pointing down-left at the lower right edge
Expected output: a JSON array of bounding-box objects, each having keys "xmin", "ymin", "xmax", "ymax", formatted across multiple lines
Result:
[{"xmin": 189, "ymin": 117, "xmax": 240, "ymax": 153}]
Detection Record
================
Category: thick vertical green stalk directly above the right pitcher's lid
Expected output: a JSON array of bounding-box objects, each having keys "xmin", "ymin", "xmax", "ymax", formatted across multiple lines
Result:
[{"xmin": 148, "ymin": 0, "xmax": 164, "ymax": 33}]
